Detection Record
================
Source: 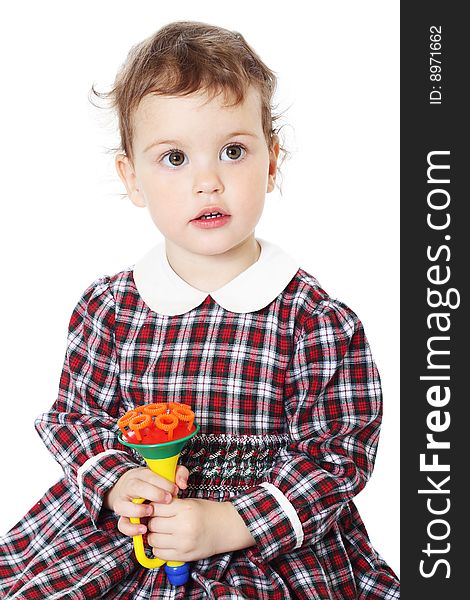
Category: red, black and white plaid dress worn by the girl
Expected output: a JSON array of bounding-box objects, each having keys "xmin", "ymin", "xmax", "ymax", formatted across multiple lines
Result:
[{"xmin": 0, "ymin": 240, "xmax": 399, "ymax": 600}]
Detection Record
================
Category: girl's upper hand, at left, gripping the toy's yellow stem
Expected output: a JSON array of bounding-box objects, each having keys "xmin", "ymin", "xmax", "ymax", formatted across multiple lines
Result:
[{"xmin": 104, "ymin": 465, "xmax": 189, "ymax": 536}]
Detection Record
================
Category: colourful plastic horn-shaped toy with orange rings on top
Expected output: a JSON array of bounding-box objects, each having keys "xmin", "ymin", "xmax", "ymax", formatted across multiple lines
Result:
[{"xmin": 117, "ymin": 402, "xmax": 199, "ymax": 586}]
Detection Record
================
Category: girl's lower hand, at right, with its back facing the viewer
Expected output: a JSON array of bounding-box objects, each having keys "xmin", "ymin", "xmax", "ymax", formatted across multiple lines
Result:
[{"xmin": 147, "ymin": 498, "xmax": 256, "ymax": 562}]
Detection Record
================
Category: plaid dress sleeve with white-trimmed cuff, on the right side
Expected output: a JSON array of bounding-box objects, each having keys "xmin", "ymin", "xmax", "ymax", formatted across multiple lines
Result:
[{"xmin": 232, "ymin": 301, "xmax": 382, "ymax": 560}]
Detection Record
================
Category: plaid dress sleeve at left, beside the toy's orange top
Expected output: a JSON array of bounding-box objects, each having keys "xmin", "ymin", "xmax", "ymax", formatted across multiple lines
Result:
[{"xmin": 35, "ymin": 277, "xmax": 140, "ymax": 526}]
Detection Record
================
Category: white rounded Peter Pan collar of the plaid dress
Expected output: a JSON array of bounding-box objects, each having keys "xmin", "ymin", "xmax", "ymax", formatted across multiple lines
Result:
[{"xmin": 133, "ymin": 238, "xmax": 299, "ymax": 316}]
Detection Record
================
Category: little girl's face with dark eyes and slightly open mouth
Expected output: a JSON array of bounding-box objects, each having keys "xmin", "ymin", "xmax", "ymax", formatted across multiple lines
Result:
[{"xmin": 116, "ymin": 87, "xmax": 279, "ymax": 255}]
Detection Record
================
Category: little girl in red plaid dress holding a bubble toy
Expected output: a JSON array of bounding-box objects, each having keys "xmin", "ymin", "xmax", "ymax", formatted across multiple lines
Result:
[{"xmin": 0, "ymin": 21, "xmax": 399, "ymax": 600}]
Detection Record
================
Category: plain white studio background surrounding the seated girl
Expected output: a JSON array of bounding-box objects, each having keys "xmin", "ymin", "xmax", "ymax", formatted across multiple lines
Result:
[{"xmin": 0, "ymin": 0, "xmax": 399, "ymax": 572}]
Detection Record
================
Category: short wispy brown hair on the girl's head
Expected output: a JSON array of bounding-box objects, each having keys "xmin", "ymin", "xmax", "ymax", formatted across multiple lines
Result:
[{"xmin": 91, "ymin": 21, "xmax": 289, "ymax": 190}]
